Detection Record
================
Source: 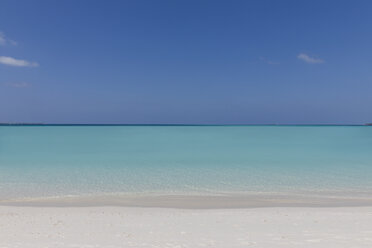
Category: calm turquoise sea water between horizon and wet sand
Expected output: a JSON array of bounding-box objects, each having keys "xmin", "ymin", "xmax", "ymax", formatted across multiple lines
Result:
[{"xmin": 0, "ymin": 126, "xmax": 372, "ymax": 200}]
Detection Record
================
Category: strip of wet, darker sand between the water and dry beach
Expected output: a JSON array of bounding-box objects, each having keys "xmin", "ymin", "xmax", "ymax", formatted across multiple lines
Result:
[{"xmin": 0, "ymin": 193, "xmax": 372, "ymax": 209}]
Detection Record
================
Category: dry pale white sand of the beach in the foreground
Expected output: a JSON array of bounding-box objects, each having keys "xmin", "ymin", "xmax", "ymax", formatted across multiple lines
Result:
[{"xmin": 0, "ymin": 206, "xmax": 372, "ymax": 248}]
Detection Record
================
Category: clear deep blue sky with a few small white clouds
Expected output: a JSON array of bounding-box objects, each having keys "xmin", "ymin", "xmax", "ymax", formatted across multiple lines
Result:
[{"xmin": 0, "ymin": 0, "xmax": 372, "ymax": 124}]
